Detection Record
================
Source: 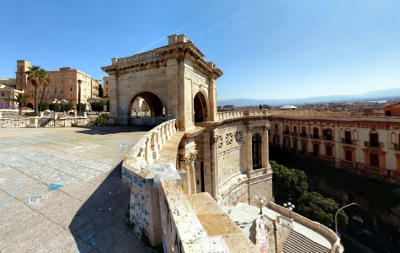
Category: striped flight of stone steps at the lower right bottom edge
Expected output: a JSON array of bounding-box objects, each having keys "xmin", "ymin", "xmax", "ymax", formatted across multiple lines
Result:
[{"xmin": 282, "ymin": 229, "xmax": 330, "ymax": 253}]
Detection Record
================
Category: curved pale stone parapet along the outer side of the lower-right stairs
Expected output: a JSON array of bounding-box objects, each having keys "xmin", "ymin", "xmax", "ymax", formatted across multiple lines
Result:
[{"xmin": 267, "ymin": 202, "xmax": 343, "ymax": 253}]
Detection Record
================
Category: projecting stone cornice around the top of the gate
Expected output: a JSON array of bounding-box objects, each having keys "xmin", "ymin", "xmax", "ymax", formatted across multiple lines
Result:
[{"xmin": 101, "ymin": 41, "xmax": 223, "ymax": 79}]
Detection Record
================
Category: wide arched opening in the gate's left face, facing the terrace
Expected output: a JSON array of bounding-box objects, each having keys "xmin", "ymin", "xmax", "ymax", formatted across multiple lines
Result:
[{"xmin": 127, "ymin": 92, "xmax": 166, "ymax": 125}]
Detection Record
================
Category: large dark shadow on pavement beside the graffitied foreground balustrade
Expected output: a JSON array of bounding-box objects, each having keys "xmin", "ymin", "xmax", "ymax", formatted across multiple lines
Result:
[{"xmin": 69, "ymin": 164, "xmax": 156, "ymax": 253}]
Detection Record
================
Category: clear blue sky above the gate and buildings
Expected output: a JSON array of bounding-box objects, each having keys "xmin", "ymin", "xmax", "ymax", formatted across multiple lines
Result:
[{"xmin": 0, "ymin": 0, "xmax": 400, "ymax": 99}]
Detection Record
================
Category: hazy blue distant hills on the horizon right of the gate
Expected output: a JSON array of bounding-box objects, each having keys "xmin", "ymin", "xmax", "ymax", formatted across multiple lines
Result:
[{"xmin": 218, "ymin": 88, "xmax": 400, "ymax": 106}]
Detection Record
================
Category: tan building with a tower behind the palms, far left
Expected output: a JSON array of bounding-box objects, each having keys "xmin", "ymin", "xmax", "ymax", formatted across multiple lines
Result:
[{"xmin": 16, "ymin": 60, "xmax": 98, "ymax": 105}]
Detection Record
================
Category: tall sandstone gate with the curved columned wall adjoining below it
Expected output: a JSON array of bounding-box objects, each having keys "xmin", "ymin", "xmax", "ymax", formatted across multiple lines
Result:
[{"xmin": 102, "ymin": 35, "xmax": 272, "ymax": 203}]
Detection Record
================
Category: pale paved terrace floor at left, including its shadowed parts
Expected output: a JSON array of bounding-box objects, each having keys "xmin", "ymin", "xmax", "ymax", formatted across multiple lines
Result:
[{"xmin": 0, "ymin": 127, "xmax": 159, "ymax": 253}]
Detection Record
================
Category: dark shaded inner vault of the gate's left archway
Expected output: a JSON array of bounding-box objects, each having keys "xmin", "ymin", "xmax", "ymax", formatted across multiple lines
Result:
[{"xmin": 128, "ymin": 91, "xmax": 165, "ymax": 117}]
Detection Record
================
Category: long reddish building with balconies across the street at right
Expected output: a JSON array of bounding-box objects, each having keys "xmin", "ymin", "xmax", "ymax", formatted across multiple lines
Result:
[{"xmin": 270, "ymin": 113, "xmax": 400, "ymax": 182}]
